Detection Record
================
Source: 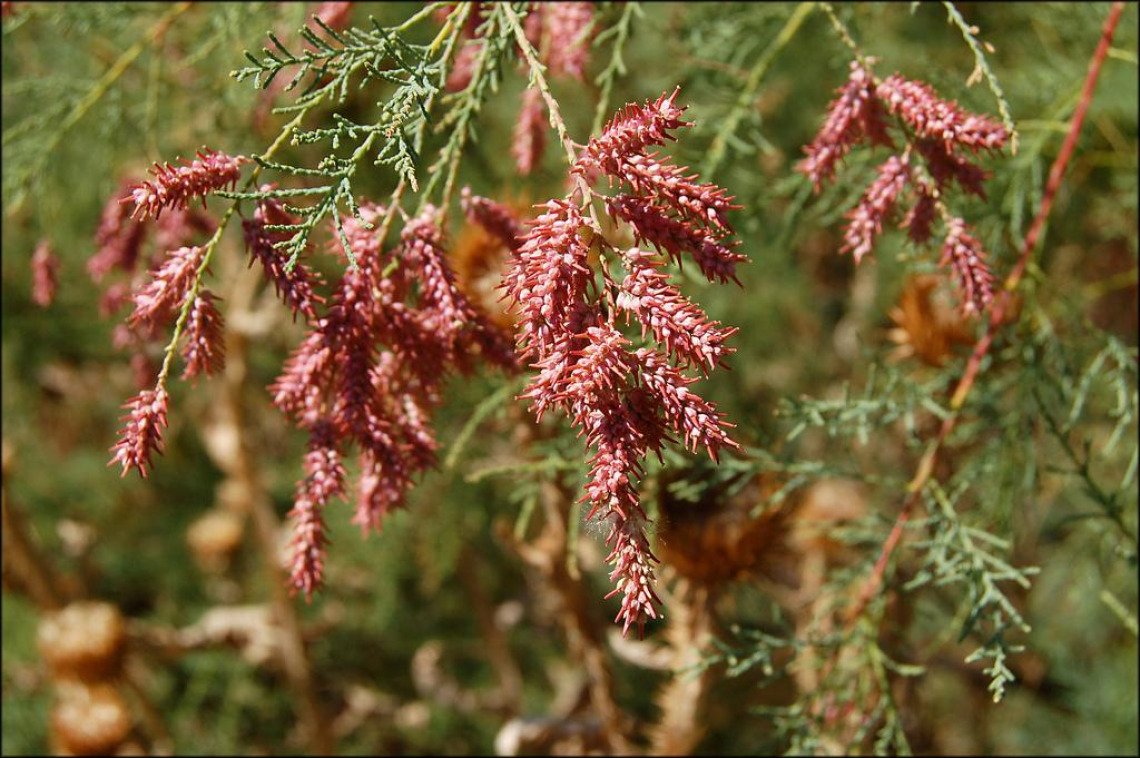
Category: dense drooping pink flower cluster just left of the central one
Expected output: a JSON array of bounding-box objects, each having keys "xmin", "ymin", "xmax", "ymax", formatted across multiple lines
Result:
[{"xmin": 262, "ymin": 201, "xmax": 514, "ymax": 595}]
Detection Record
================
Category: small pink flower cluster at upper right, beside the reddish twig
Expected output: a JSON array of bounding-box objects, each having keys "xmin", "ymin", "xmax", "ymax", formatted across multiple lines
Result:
[{"xmin": 798, "ymin": 62, "xmax": 1009, "ymax": 313}]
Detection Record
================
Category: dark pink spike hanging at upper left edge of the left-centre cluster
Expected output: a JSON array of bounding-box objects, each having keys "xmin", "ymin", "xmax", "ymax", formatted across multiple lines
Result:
[{"xmin": 242, "ymin": 190, "xmax": 323, "ymax": 321}]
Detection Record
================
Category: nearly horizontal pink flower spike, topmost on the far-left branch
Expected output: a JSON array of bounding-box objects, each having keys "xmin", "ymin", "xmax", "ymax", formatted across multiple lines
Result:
[{"xmin": 131, "ymin": 149, "xmax": 250, "ymax": 220}]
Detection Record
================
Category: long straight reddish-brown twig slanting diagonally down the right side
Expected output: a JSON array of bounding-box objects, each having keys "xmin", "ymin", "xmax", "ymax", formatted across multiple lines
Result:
[{"xmin": 847, "ymin": 2, "xmax": 1124, "ymax": 628}]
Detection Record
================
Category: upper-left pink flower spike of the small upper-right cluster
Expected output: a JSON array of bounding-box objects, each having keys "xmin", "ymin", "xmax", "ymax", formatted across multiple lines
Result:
[{"xmin": 796, "ymin": 60, "xmax": 891, "ymax": 191}]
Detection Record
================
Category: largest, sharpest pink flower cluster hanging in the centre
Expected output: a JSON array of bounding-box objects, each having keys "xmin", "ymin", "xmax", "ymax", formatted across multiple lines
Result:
[{"xmin": 504, "ymin": 91, "xmax": 744, "ymax": 633}]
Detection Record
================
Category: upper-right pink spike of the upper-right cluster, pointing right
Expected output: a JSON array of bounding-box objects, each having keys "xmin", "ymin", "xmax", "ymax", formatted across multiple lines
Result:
[{"xmin": 876, "ymin": 74, "xmax": 1009, "ymax": 152}]
